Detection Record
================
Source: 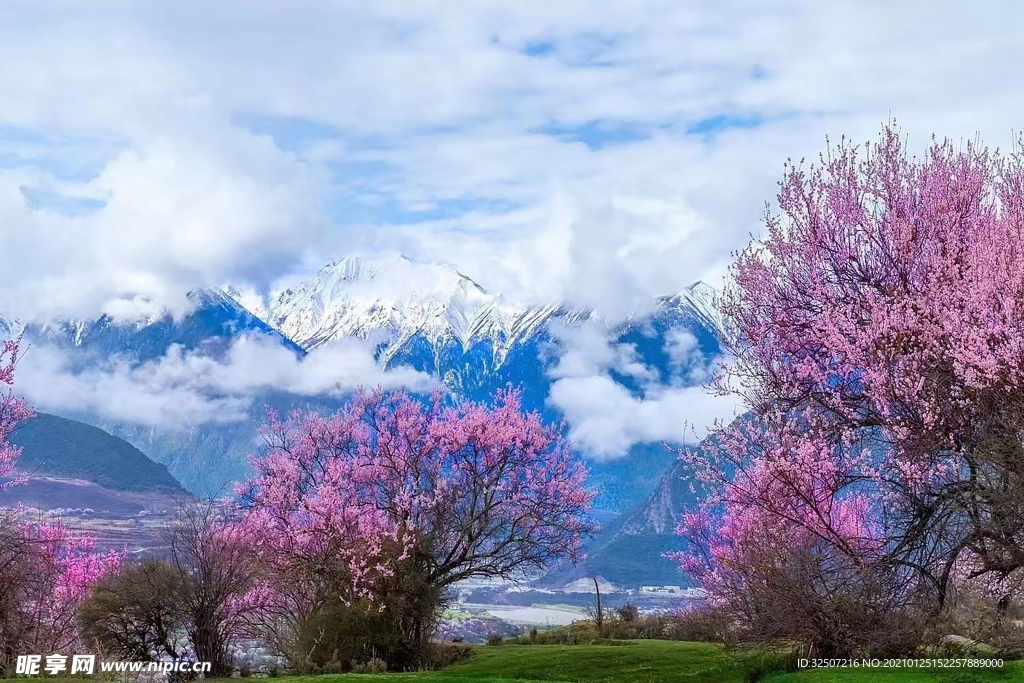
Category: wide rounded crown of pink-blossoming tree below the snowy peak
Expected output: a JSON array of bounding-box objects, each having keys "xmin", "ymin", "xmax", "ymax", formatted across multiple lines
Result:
[{"xmin": 239, "ymin": 391, "xmax": 595, "ymax": 655}]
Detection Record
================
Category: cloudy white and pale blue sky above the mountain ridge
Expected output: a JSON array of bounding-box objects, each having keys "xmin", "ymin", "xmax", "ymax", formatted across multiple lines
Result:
[{"xmin": 0, "ymin": 0, "xmax": 1024, "ymax": 454}]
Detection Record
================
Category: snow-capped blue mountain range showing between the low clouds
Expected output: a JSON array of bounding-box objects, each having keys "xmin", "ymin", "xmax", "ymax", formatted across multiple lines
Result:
[{"xmin": 0, "ymin": 253, "xmax": 725, "ymax": 520}]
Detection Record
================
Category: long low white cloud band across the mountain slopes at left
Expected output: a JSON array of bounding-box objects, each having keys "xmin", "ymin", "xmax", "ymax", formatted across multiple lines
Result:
[{"xmin": 17, "ymin": 336, "xmax": 435, "ymax": 427}]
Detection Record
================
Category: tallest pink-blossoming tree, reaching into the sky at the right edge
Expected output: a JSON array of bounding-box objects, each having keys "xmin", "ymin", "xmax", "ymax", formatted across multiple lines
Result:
[{"xmin": 680, "ymin": 127, "xmax": 1024, "ymax": 651}]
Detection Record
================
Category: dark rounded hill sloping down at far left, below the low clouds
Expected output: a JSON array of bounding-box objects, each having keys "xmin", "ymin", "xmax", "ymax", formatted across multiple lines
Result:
[{"xmin": 10, "ymin": 413, "xmax": 183, "ymax": 494}]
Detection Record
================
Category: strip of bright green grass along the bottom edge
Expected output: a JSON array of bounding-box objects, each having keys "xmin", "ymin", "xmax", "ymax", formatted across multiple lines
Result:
[{"xmin": 2, "ymin": 640, "xmax": 1024, "ymax": 683}]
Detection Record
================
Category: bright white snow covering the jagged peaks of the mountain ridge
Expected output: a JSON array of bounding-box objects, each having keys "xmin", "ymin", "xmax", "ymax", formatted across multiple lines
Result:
[{"xmin": 0, "ymin": 257, "xmax": 731, "ymax": 368}]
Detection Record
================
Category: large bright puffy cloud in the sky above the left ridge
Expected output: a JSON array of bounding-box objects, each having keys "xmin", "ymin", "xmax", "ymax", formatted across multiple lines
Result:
[{"xmin": 0, "ymin": 114, "xmax": 324, "ymax": 318}]
